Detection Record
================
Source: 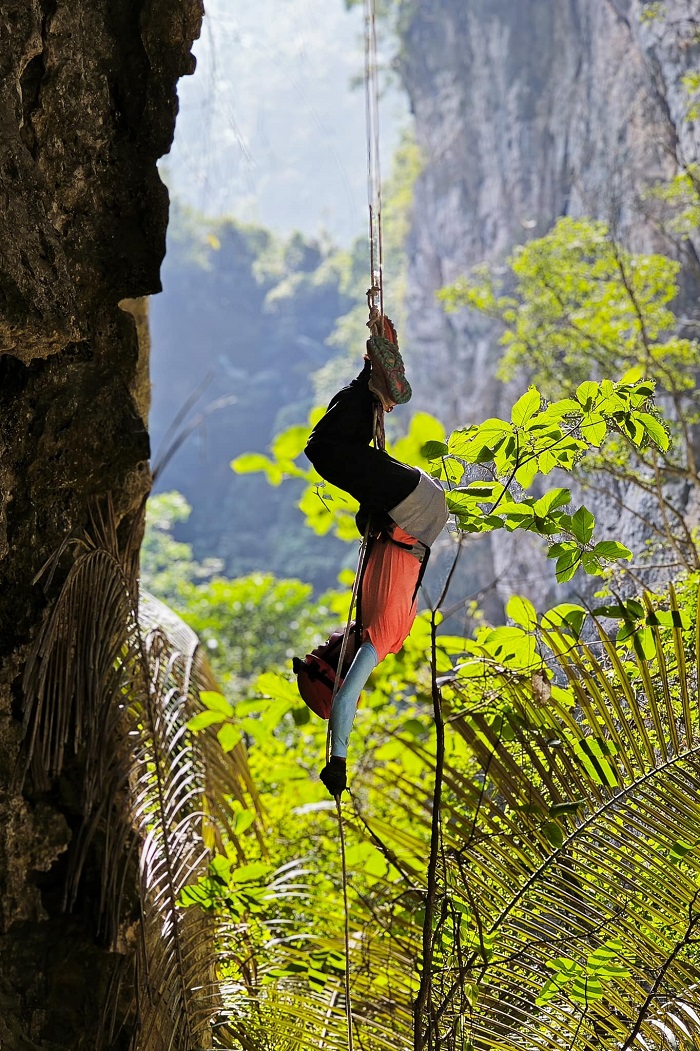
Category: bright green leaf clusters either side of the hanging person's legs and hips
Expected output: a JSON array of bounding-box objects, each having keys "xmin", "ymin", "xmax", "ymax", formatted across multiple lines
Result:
[{"xmin": 237, "ymin": 379, "xmax": 668, "ymax": 582}]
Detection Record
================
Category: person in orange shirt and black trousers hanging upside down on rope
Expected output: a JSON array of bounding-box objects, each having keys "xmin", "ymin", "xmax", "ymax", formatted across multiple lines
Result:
[{"xmin": 294, "ymin": 316, "xmax": 448, "ymax": 796}]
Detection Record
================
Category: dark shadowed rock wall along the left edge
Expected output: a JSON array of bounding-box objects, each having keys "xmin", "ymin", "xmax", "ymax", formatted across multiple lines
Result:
[{"xmin": 0, "ymin": 0, "xmax": 202, "ymax": 1051}]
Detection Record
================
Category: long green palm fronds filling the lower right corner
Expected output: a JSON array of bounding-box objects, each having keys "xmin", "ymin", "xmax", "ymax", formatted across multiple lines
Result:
[{"xmin": 397, "ymin": 599, "xmax": 700, "ymax": 1049}]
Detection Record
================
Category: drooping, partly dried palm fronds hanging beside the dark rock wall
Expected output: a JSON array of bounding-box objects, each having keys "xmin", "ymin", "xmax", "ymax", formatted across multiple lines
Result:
[{"xmin": 23, "ymin": 502, "xmax": 261, "ymax": 1051}]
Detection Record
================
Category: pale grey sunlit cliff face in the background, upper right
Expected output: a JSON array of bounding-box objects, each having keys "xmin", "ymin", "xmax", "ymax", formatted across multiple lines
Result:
[{"xmin": 400, "ymin": 0, "xmax": 700, "ymax": 600}]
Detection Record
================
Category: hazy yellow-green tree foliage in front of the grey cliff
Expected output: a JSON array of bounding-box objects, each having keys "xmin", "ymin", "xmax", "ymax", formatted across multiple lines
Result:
[{"xmin": 440, "ymin": 215, "xmax": 700, "ymax": 569}]
